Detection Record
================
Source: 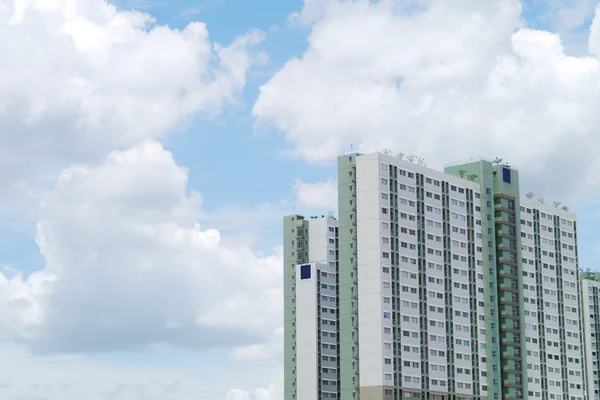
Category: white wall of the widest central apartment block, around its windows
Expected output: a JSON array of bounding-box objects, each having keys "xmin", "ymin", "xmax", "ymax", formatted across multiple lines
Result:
[{"xmin": 356, "ymin": 154, "xmax": 487, "ymax": 396}]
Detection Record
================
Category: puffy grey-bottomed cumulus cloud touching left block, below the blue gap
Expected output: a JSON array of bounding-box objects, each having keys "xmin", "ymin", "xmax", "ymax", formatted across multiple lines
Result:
[{"xmin": 0, "ymin": 142, "xmax": 282, "ymax": 358}]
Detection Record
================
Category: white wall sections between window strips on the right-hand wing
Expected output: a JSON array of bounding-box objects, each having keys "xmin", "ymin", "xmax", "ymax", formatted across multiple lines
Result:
[{"xmin": 519, "ymin": 198, "xmax": 592, "ymax": 399}]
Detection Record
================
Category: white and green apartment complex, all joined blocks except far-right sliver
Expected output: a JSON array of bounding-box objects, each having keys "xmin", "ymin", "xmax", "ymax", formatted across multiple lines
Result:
[{"xmin": 284, "ymin": 153, "xmax": 586, "ymax": 400}]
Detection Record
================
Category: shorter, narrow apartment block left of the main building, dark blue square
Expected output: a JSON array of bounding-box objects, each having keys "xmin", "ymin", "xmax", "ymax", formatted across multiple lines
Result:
[{"xmin": 283, "ymin": 215, "xmax": 339, "ymax": 400}]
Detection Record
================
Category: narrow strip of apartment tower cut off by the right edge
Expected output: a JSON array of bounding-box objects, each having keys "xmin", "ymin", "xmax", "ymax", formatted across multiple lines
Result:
[{"xmin": 581, "ymin": 274, "xmax": 600, "ymax": 400}]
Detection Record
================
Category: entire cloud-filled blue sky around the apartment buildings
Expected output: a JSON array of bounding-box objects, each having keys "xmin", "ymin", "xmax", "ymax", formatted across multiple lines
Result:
[{"xmin": 0, "ymin": 0, "xmax": 600, "ymax": 400}]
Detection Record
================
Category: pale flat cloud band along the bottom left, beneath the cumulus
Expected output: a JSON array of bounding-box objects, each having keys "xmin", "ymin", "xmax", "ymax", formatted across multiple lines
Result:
[{"xmin": 0, "ymin": 343, "xmax": 282, "ymax": 400}]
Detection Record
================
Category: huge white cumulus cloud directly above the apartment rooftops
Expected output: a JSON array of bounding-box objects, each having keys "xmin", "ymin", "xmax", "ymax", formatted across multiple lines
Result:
[{"xmin": 253, "ymin": 0, "xmax": 600, "ymax": 200}]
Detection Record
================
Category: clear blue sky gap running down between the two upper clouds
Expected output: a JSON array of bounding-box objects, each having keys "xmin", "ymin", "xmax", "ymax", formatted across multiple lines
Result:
[{"xmin": 125, "ymin": 0, "xmax": 332, "ymax": 208}]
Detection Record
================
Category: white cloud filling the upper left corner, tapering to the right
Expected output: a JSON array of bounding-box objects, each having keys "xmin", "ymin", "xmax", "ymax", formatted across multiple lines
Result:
[{"xmin": 0, "ymin": 0, "xmax": 263, "ymax": 202}]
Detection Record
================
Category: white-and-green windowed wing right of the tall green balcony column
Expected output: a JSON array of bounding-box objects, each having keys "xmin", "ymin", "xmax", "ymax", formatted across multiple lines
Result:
[{"xmin": 520, "ymin": 199, "xmax": 587, "ymax": 400}]
